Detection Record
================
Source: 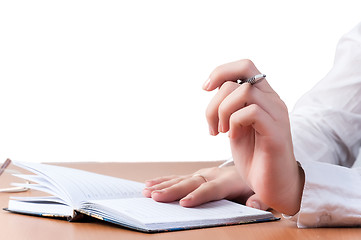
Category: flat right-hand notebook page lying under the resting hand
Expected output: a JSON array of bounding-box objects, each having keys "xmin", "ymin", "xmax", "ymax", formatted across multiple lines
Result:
[{"xmin": 83, "ymin": 198, "xmax": 272, "ymax": 228}]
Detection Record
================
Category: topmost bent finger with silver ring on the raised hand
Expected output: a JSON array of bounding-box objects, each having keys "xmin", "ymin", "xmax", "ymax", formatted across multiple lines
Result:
[{"xmin": 203, "ymin": 59, "xmax": 273, "ymax": 92}]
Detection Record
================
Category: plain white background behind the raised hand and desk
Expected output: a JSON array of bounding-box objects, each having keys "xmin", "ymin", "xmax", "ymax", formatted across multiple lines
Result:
[{"xmin": 0, "ymin": 0, "xmax": 361, "ymax": 162}]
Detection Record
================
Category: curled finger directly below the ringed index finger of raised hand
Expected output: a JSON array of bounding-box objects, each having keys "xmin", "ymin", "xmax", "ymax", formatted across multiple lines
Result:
[{"xmin": 206, "ymin": 82, "xmax": 240, "ymax": 136}]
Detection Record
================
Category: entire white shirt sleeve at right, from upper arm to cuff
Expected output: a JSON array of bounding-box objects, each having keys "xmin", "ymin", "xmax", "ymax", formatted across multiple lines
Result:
[{"xmin": 290, "ymin": 23, "xmax": 361, "ymax": 227}]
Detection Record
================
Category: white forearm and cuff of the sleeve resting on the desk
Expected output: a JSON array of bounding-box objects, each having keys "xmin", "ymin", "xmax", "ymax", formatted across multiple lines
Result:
[{"xmin": 291, "ymin": 161, "xmax": 361, "ymax": 228}]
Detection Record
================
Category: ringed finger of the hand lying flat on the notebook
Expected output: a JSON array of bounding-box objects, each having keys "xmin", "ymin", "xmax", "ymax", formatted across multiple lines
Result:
[{"xmin": 152, "ymin": 176, "xmax": 205, "ymax": 202}]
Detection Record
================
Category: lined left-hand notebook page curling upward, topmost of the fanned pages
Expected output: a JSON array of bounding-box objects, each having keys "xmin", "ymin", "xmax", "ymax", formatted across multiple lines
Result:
[{"xmin": 14, "ymin": 162, "xmax": 144, "ymax": 208}]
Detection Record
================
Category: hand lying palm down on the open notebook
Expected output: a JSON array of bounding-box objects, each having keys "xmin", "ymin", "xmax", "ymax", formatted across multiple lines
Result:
[{"xmin": 143, "ymin": 166, "xmax": 268, "ymax": 210}]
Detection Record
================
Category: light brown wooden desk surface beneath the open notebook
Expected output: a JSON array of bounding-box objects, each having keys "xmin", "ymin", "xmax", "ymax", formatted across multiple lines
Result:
[{"xmin": 0, "ymin": 162, "xmax": 361, "ymax": 240}]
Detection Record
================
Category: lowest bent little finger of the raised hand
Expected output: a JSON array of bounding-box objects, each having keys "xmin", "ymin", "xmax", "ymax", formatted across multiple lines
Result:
[{"xmin": 229, "ymin": 104, "xmax": 274, "ymax": 139}]
